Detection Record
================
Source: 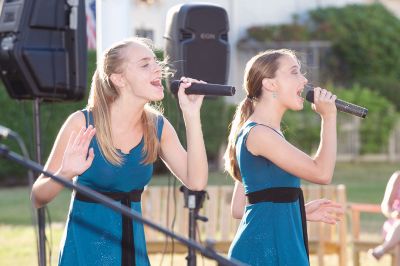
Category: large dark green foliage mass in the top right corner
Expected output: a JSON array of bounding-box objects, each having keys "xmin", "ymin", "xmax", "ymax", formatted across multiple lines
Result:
[{"xmin": 247, "ymin": 4, "xmax": 400, "ymax": 110}]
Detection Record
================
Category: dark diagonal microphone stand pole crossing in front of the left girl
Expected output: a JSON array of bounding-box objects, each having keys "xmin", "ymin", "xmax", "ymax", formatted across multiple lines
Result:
[{"xmin": 0, "ymin": 144, "xmax": 246, "ymax": 266}]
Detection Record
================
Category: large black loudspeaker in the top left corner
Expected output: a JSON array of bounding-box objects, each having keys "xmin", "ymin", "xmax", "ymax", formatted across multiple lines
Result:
[{"xmin": 0, "ymin": 0, "xmax": 87, "ymax": 101}]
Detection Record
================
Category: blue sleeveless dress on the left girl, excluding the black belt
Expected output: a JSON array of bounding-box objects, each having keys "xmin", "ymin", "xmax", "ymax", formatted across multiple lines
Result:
[{"xmin": 59, "ymin": 110, "xmax": 164, "ymax": 266}]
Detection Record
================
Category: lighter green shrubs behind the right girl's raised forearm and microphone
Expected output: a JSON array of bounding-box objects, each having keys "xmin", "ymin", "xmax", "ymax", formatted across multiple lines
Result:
[{"xmin": 282, "ymin": 85, "xmax": 399, "ymax": 154}]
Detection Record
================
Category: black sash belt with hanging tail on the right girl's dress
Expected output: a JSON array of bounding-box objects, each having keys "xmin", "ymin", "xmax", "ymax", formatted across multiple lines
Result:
[{"xmin": 246, "ymin": 187, "xmax": 309, "ymax": 257}]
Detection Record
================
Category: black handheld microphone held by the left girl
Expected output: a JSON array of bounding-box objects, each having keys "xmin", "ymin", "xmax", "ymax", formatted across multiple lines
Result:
[{"xmin": 170, "ymin": 80, "xmax": 236, "ymax": 96}]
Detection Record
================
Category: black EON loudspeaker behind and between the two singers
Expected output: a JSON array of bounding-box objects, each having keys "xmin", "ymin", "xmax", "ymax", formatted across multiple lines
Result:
[{"xmin": 165, "ymin": 4, "xmax": 229, "ymax": 84}]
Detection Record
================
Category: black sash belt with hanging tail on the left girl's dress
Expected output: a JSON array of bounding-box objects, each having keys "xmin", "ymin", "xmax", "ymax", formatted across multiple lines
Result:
[{"xmin": 75, "ymin": 189, "xmax": 143, "ymax": 266}]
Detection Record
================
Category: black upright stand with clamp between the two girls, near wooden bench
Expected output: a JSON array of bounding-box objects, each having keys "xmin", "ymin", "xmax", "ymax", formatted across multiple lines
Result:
[{"xmin": 179, "ymin": 186, "xmax": 208, "ymax": 266}]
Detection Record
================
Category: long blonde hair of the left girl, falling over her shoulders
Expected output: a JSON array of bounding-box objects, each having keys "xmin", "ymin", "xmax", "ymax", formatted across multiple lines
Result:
[{"xmin": 87, "ymin": 38, "xmax": 160, "ymax": 165}]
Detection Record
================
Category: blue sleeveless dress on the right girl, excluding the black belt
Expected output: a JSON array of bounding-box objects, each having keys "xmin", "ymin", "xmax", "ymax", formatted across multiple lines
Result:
[{"xmin": 228, "ymin": 122, "xmax": 309, "ymax": 266}]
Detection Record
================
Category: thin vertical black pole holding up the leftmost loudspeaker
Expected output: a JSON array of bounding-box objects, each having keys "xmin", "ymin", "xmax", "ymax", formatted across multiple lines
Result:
[{"xmin": 33, "ymin": 98, "xmax": 46, "ymax": 266}]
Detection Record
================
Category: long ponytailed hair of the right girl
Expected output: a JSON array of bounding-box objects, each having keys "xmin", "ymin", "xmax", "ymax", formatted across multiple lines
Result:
[{"xmin": 224, "ymin": 49, "xmax": 296, "ymax": 181}]
